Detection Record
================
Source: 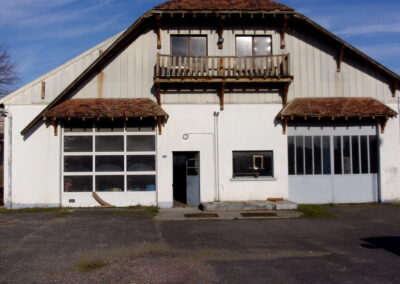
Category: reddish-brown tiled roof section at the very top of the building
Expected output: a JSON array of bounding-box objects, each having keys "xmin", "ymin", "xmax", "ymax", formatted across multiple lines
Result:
[{"xmin": 153, "ymin": 0, "xmax": 294, "ymax": 11}]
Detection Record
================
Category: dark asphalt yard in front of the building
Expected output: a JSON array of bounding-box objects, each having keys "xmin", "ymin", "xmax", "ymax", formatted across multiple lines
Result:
[{"xmin": 0, "ymin": 205, "xmax": 400, "ymax": 283}]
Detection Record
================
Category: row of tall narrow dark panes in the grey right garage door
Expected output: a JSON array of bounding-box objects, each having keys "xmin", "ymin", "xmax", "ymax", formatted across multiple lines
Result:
[{"xmin": 288, "ymin": 135, "xmax": 378, "ymax": 175}]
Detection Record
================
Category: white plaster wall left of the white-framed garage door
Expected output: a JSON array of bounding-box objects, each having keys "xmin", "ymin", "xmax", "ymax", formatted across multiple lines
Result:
[{"xmin": 4, "ymin": 105, "xmax": 60, "ymax": 208}]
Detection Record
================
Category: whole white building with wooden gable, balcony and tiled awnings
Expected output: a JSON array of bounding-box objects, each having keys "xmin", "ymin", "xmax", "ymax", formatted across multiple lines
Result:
[{"xmin": 0, "ymin": 0, "xmax": 400, "ymax": 208}]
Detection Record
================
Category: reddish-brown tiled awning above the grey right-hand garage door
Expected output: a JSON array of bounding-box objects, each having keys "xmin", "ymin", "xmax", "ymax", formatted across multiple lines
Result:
[{"xmin": 279, "ymin": 98, "xmax": 397, "ymax": 118}]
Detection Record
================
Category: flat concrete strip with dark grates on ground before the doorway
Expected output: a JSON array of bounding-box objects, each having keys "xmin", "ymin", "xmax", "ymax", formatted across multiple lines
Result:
[{"xmin": 154, "ymin": 207, "xmax": 302, "ymax": 221}]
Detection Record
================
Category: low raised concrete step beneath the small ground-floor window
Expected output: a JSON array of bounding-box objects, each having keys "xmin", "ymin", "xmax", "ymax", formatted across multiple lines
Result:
[{"xmin": 200, "ymin": 200, "xmax": 297, "ymax": 211}]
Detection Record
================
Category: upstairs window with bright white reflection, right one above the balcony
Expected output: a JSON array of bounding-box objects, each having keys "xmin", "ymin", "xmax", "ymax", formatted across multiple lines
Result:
[{"xmin": 236, "ymin": 36, "xmax": 272, "ymax": 56}]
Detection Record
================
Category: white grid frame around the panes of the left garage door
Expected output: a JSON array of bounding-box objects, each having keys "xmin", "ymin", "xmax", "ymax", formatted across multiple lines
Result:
[{"xmin": 60, "ymin": 121, "xmax": 158, "ymax": 194}]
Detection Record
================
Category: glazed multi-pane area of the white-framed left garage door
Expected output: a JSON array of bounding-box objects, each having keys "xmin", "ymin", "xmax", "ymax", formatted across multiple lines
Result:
[{"xmin": 63, "ymin": 119, "xmax": 156, "ymax": 192}]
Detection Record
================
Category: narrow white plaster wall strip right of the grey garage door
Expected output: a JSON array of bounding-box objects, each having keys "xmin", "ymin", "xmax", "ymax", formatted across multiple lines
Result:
[{"xmin": 380, "ymin": 104, "xmax": 400, "ymax": 202}]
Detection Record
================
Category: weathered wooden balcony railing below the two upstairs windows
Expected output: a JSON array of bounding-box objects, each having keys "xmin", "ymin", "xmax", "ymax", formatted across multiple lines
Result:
[{"xmin": 155, "ymin": 54, "xmax": 291, "ymax": 82}]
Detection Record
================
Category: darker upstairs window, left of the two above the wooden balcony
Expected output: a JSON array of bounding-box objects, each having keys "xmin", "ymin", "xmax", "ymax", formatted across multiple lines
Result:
[{"xmin": 171, "ymin": 35, "xmax": 207, "ymax": 56}]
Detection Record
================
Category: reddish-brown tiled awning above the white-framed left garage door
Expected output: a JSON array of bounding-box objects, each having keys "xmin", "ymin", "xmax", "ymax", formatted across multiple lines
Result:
[{"xmin": 43, "ymin": 98, "xmax": 168, "ymax": 119}]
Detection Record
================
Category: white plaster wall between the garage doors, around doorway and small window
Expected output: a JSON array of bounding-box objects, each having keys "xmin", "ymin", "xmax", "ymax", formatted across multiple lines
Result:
[{"xmin": 157, "ymin": 101, "xmax": 288, "ymax": 207}]
